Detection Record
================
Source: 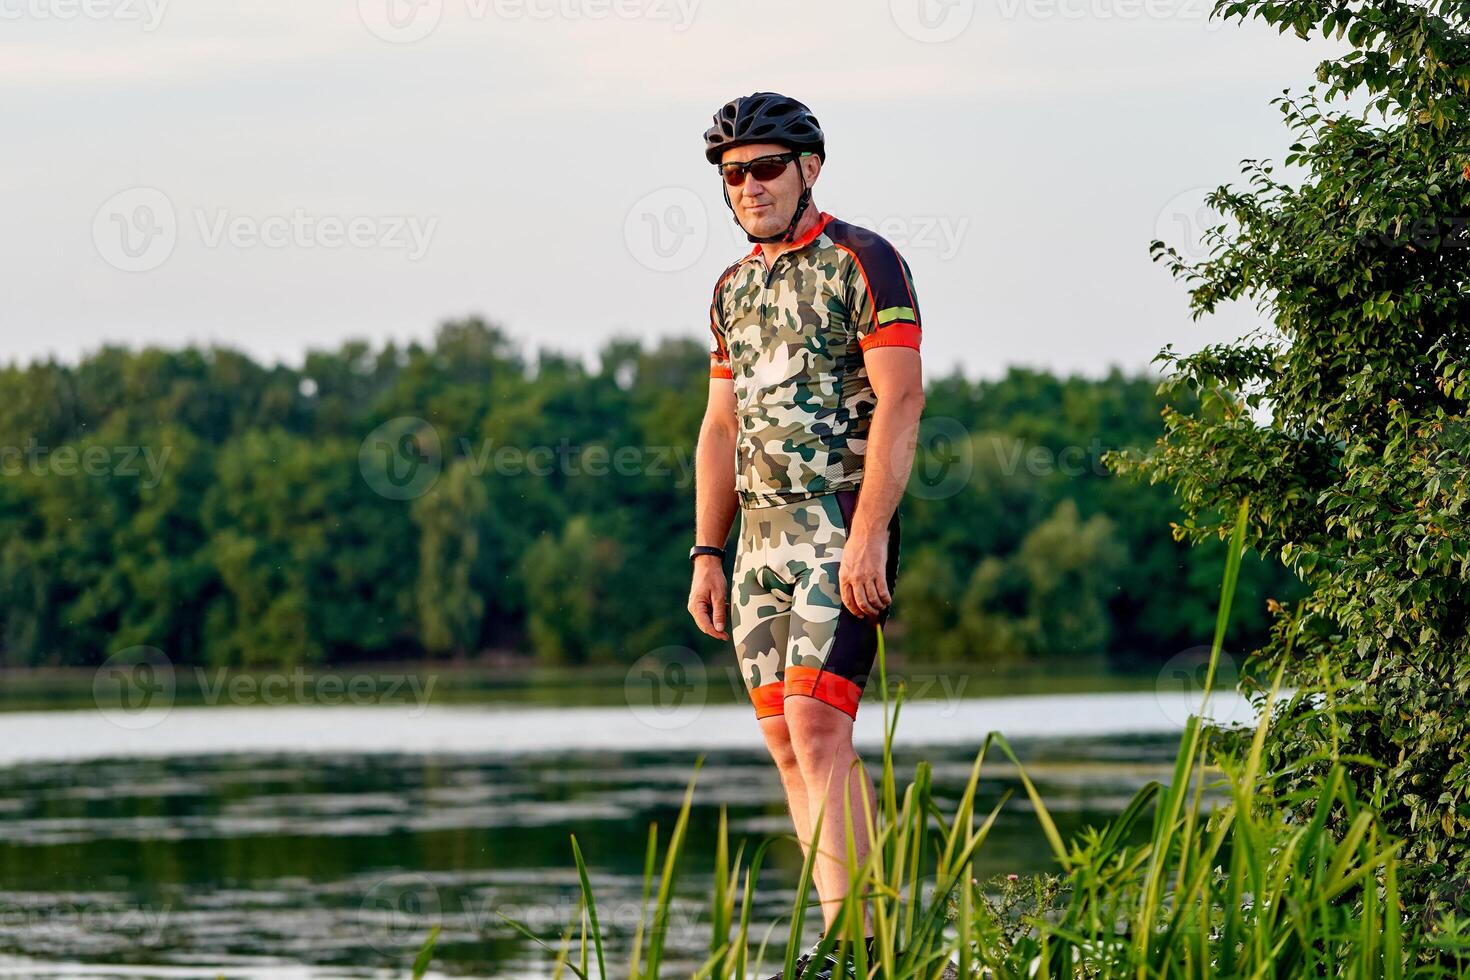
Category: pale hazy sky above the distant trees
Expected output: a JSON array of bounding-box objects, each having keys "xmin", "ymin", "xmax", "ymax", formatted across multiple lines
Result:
[{"xmin": 0, "ymin": 0, "xmax": 1338, "ymax": 378}]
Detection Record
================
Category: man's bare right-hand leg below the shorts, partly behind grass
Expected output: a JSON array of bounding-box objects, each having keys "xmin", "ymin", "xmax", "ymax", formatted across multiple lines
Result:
[{"xmin": 785, "ymin": 695, "xmax": 878, "ymax": 936}]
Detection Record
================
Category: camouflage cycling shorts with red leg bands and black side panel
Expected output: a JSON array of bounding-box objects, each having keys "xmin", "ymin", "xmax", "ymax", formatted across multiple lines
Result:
[{"xmin": 731, "ymin": 489, "xmax": 898, "ymax": 718}]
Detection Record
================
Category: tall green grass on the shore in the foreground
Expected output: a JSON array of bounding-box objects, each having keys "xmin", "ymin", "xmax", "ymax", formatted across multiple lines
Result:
[{"xmin": 476, "ymin": 501, "xmax": 1470, "ymax": 980}]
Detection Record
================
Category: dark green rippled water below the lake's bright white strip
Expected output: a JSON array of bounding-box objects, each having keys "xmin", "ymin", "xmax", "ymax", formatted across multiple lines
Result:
[{"xmin": 0, "ymin": 718, "xmax": 1193, "ymax": 980}]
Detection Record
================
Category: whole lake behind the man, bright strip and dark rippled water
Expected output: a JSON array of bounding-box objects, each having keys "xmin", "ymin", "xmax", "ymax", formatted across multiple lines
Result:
[{"xmin": 0, "ymin": 664, "xmax": 1251, "ymax": 980}]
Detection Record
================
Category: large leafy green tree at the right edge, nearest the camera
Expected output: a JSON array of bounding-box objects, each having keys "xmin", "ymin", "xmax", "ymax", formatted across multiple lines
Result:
[{"xmin": 1113, "ymin": 0, "xmax": 1470, "ymax": 914}]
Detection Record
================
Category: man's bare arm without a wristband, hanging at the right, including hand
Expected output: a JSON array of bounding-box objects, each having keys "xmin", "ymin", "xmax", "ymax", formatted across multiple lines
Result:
[{"xmin": 841, "ymin": 347, "xmax": 923, "ymax": 616}]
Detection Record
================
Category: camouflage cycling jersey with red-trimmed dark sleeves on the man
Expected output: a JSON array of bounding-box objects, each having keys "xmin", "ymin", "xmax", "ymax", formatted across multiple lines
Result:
[{"xmin": 710, "ymin": 212, "xmax": 920, "ymax": 507}]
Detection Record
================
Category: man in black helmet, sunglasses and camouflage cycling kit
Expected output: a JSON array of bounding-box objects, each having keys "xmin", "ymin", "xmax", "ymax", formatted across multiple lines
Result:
[{"xmin": 689, "ymin": 93, "xmax": 923, "ymax": 977}]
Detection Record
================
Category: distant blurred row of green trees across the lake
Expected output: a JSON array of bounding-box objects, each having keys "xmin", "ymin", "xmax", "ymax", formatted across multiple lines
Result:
[{"xmin": 0, "ymin": 326, "xmax": 1294, "ymax": 667}]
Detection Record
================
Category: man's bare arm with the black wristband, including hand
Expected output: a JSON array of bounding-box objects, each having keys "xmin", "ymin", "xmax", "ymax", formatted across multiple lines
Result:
[{"xmin": 689, "ymin": 378, "xmax": 738, "ymax": 639}]
